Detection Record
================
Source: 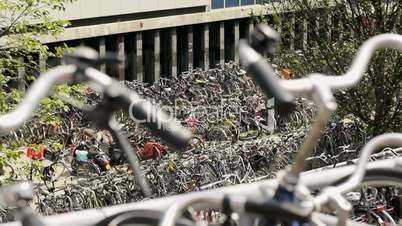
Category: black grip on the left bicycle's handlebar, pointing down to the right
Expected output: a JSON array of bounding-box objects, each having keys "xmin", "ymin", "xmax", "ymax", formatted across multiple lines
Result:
[{"xmin": 109, "ymin": 84, "xmax": 192, "ymax": 149}]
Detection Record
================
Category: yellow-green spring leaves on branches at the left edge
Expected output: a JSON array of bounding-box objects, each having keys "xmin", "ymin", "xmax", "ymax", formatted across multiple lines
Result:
[{"xmin": 0, "ymin": 0, "xmax": 74, "ymax": 176}]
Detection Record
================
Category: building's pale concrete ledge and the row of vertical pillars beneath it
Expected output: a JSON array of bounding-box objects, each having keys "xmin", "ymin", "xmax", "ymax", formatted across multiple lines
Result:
[{"xmin": 41, "ymin": 0, "xmax": 308, "ymax": 83}]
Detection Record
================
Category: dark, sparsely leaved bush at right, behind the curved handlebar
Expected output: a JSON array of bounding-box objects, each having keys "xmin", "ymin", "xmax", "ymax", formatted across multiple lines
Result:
[{"xmin": 257, "ymin": 0, "xmax": 402, "ymax": 134}]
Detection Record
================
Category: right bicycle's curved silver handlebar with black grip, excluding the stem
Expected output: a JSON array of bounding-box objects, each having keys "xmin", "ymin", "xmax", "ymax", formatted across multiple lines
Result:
[{"xmin": 238, "ymin": 31, "xmax": 402, "ymax": 107}]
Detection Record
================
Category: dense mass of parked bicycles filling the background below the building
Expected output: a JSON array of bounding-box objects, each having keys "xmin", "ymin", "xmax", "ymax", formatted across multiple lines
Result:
[{"xmin": 0, "ymin": 63, "xmax": 367, "ymax": 215}]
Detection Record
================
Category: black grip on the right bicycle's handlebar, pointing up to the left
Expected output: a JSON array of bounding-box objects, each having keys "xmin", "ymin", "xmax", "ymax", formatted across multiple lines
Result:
[{"xmin": 239, "ymin": 40, "xmax": 294, "ymax": 112}]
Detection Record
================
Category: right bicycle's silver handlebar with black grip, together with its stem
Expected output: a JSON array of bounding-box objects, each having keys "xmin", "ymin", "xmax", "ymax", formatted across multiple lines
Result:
[{"xmin": 239, "ymin": 30, "xmax": 402, "ymax": 175}]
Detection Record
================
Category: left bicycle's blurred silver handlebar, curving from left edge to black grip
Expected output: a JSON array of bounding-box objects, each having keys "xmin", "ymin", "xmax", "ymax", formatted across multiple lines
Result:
[{"xmin": 0, "ymin": 65, "xmax": 191, "ymax": 149}]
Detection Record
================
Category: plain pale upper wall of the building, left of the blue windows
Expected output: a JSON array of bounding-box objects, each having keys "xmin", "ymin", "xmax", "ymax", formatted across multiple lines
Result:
[{"xmin": 54, "ymin": 0, "xmax": 210, "ymax": 20}]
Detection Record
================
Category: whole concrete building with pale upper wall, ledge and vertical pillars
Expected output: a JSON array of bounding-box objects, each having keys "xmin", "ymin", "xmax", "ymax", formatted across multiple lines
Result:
[{"xmin": 42, "ymin": 0, "xmax": 288, "ymax": 82}]
